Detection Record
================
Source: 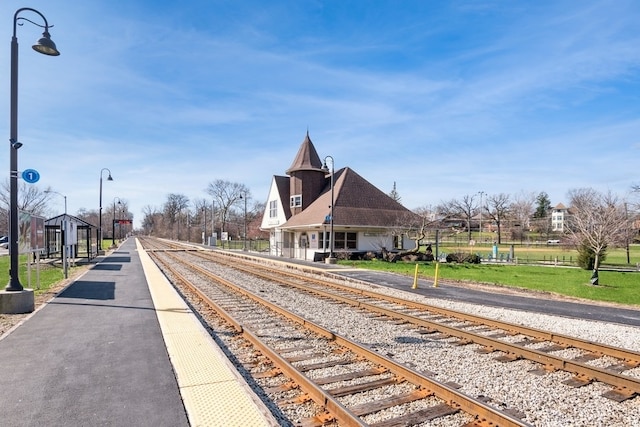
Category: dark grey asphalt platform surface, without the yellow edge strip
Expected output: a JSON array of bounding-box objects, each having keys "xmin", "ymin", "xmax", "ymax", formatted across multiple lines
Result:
[{"xmin": 0, "ymin": 239, "xmax": 189, "ymax": 427}]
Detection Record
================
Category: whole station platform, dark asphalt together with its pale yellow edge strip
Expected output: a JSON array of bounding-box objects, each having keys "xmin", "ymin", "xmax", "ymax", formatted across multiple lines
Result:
[{"xmin": 0, "ymin": 239, "xmax": 277, "ymax": 427}]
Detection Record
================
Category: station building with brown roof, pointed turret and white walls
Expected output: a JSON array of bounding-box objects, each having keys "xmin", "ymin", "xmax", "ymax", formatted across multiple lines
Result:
[{"xmin": 260, "ymin": 133, "xmax": 419, "ymax": 261}]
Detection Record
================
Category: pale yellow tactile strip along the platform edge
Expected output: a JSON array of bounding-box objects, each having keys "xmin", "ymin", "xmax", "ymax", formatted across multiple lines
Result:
[{"xmin": 136, "ymin": 240, "xmax": 278, "ymax": 427}]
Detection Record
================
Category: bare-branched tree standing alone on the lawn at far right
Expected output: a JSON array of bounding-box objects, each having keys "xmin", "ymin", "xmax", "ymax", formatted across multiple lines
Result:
[{"xmin": 567, "ymin": 188, "xmax": 629, "ymax": 285}]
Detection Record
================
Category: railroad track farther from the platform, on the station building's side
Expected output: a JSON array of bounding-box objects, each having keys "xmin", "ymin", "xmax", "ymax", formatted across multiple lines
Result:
[{"xmin": 184, "ymin": 247, "xmax": 640, "ymax": 402}]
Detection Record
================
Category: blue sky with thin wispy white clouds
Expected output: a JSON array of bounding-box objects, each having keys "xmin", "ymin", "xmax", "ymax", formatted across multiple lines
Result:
[{"xmin": 0, "ymin": 0, "xmax": 640, "ymax": 231}]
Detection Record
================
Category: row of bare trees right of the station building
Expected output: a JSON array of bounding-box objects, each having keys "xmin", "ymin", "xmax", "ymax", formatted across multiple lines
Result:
[{"xmin": 416, "ymin": 188, "xmax": 640, "ymax": 284}]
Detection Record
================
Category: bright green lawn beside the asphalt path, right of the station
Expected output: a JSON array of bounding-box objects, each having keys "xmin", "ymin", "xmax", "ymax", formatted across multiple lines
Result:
[{"xmin": 340, "ymin": 258, "xmax": 640, "ymax": 305}]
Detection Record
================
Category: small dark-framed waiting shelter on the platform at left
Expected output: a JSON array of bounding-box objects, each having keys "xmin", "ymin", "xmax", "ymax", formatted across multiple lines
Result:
[{"xmin": 44, "ymin": 214, "xmax": 98, "ymax": 260}]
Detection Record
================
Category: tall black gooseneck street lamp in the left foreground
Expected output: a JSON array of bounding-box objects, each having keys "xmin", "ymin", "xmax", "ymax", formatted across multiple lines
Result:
[{"xmin": 5, "ymin": 7, "xmax": 60, "ymax": 291}]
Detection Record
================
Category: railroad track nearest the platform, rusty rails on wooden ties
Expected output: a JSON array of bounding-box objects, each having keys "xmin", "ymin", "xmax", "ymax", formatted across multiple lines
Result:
[{"xmin": 143, "ymin": 239, "xmax": 528, "ymax": 427}]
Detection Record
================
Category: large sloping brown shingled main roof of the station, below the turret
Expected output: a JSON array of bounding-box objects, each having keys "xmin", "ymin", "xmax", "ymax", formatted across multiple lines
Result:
[{"xmin": 282, "ymin": 167, "xmax": 417, "ymax": 228}]
